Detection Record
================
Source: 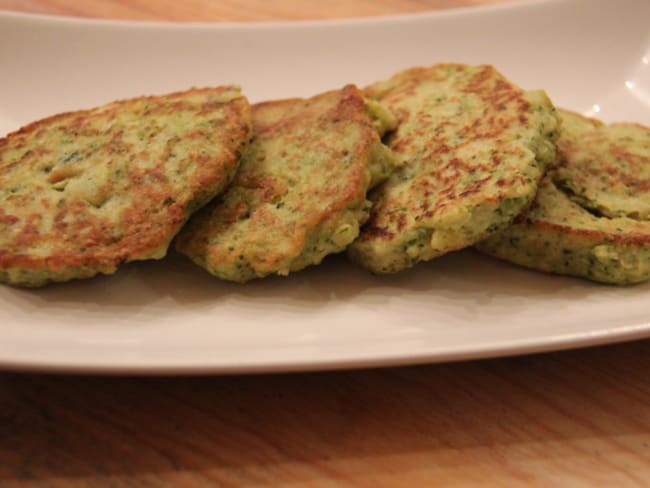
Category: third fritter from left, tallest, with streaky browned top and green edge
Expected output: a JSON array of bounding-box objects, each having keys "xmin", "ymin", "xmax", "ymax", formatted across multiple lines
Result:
[{"xmin": 349, "ymin": 64, "xmax": 557, "ymax": 273}]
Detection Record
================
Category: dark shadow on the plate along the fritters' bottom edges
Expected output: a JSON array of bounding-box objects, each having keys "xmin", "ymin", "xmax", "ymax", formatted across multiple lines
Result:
[{"xmin": 2, "ymin": 250, "xmax": 624, "ymax": 308}]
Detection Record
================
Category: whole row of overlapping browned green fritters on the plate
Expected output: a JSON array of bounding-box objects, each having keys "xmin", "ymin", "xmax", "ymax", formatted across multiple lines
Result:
[{"xmin": 0, "ymin": 64, "xmax": 650, "ymax": 286}]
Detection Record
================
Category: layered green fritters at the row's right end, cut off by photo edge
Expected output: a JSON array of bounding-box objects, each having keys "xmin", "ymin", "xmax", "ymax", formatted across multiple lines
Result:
[{"xmin": 477, "ymin": 111, "xmax": 650, "ymax": 284}]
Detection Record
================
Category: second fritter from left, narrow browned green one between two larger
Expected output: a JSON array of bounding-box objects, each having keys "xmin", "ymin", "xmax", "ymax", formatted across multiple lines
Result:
[{"xmin": 176, "ymin": 85, "xmax": 395, "ymax": 282}]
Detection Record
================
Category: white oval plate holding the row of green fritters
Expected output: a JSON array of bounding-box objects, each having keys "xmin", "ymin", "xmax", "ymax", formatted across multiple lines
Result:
[{"xmin": 0, "ymin": 0, "xmax": 650, "ymax": 373}]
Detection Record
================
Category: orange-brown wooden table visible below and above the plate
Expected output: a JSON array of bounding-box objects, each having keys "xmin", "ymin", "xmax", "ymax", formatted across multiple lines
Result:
[{"xmin": 0, "ymin": 0, "xmax": 650, "ymax": 488}]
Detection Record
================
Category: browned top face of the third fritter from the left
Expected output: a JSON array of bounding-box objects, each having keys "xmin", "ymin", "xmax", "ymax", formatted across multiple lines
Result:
[{"xmin": 361, "ymin": 64, "xmax": 541, "ymax": 239}]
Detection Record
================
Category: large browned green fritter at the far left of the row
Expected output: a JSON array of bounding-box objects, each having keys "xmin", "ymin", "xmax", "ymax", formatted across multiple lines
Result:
[{"xmin": 0, "ymin": 86, "xmax": 251, "ymax": 286}]
